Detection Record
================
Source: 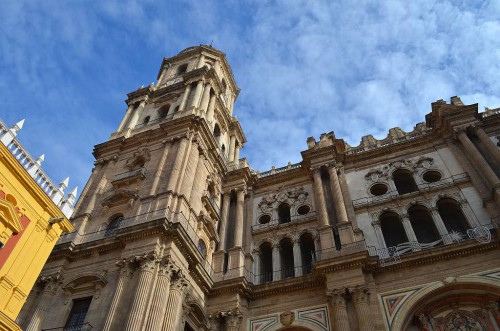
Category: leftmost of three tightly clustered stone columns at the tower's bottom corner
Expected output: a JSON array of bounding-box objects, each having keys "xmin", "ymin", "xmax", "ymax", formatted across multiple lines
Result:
[{"xmin": 125, "ymin": 253, "xmax": 159, "ymax": 331}]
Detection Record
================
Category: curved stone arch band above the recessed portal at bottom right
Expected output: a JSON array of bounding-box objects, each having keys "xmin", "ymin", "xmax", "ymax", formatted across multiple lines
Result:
[{"xmin": 390, "ymin": 275, "xmax": 500, "ymax": 330}]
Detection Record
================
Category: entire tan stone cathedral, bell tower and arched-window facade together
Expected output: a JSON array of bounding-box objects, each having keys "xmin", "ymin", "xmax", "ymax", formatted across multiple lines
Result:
[{"xmin": 19, "ymin": 46, "xmax": 500, "ymax": 331}]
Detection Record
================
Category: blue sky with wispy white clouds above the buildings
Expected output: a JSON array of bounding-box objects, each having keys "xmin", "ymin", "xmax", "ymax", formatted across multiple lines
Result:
[{"xmin": 0, "ymin": 0, "xmax": 500, "ymax": 200}]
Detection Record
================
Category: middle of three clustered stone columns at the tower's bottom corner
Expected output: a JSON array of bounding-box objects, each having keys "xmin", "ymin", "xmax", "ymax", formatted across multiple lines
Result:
[{"xmin": 146, "ymin": 257, "xmax": 177, "ymax": 331}]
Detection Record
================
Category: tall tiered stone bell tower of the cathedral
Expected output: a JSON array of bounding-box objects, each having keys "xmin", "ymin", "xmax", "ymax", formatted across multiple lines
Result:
[{"xmin": 19, "ymin": 45, "xmax": 246, "ymax": 331}]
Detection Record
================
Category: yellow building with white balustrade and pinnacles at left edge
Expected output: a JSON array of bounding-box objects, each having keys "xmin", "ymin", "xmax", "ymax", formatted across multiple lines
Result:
[{"xmin": 0, "ymin": 121, "xmax": 76, "ymax": 331}]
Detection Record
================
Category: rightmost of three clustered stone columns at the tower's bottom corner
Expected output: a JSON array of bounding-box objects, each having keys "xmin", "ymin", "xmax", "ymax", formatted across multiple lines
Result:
[{"xmin": 162, "ymin": 272, "xmax": 188, "ymax": 331}]
